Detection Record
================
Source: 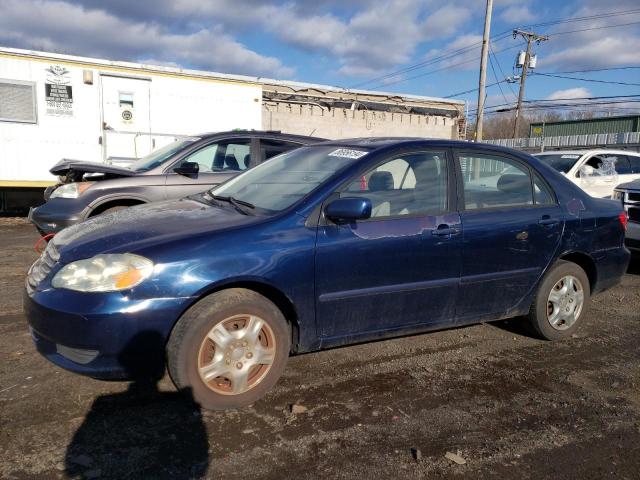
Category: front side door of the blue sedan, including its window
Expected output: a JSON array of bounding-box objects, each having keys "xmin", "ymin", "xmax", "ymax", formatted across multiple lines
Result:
[{"xmin": 315, "ymin": 150, "xmax": 461, "ymax": 344}]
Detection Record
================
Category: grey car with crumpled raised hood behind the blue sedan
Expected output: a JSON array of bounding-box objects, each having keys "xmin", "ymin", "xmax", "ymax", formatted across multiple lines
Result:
[{"xmin": 29, "ymin": 130, "xmax": 323, "ymax": 235}]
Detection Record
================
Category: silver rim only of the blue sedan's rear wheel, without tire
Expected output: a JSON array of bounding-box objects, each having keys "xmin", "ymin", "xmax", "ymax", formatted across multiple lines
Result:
[{"xmin": 547, "ymin": 275, "xmax": 584, "ymax": 330}]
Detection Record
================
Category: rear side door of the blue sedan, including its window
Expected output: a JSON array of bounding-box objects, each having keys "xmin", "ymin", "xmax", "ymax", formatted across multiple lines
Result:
[{"xmin": 456, "ymin": 150, "xmax": 563, "ymax": 322}]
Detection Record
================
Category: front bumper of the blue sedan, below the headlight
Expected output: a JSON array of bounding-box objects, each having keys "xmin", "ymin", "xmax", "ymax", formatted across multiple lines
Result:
[{"xmin": 23, "ymin": 289, "xmax": 192, "ymax": 380}]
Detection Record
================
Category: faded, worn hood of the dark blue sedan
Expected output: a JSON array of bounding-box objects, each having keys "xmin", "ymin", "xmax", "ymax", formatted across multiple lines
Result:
[{"xmin": 52, "ymin": 198, "xmax": 264, "ymax": 263}]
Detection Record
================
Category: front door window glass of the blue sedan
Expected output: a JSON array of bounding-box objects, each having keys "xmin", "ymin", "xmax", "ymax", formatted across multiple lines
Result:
[{"xmin": 341, "ymin": 152, "xmax": 447, "ymax": 218}]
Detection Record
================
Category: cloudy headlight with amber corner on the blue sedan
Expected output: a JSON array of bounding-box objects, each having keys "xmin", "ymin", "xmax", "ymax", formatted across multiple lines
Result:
[{"xmin": 51, "ymin": 253, "xmax": 153, "ymax": 292}]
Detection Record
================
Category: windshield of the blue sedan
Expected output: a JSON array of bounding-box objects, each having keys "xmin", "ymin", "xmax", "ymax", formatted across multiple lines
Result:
[{"xmin": 210, "ymin": 146, "xmax": 369, "ymax": 212}]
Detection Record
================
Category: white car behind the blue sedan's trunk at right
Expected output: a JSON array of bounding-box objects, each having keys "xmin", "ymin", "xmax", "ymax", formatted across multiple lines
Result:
[{"xmin": 535, "ymin": 149, "xmax": 640, "ymax": 198}]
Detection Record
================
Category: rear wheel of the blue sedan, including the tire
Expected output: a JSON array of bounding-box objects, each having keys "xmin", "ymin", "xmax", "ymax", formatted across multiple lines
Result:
[{"xmin": 527, "ymin": 260, "xmax": 591, "ymax": 340}]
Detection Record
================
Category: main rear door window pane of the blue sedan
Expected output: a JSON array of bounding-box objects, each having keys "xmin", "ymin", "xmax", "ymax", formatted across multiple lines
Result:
[{"xmin": 458, "ymin": 153, "xmax": 533, "ymax": 210}]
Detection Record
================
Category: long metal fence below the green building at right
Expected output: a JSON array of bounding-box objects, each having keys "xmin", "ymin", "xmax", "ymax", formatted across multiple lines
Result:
[{"xmin": 485, "ymin": 132, "xmax": 640, "ymax": 149}]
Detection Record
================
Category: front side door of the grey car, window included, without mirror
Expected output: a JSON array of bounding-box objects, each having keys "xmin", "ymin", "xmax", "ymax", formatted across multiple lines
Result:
[{"xmin": 166, "ymin": 137, "xmax": 251, "ymax": 198}]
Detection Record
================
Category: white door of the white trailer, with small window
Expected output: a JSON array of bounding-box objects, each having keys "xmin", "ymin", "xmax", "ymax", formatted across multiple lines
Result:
[{"xmin": 100, "ymin": 74, "xmax": 153, "ymax": 163}]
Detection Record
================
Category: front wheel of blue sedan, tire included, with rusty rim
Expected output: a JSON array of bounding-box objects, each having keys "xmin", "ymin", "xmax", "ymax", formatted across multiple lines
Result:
[{"xmin": 167, "ymin": 288, "xmax": 291, "ymax": 410}]
